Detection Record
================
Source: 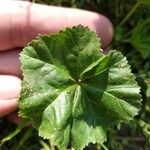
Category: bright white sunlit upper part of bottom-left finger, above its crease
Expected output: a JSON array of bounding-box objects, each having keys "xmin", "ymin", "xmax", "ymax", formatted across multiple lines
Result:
[{"xmin": 0, "ymin": 75, "xmax": 21, "ymax": 99}]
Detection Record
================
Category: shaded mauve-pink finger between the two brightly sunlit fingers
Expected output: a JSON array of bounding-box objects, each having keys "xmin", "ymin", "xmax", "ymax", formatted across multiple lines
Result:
[{"xmin": 0, "ymin": 49, "xmax": 21, "ymax": 77}]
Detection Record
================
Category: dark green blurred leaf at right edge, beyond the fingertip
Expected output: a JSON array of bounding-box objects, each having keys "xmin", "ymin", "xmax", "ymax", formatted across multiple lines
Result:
[{"xmin": 130, "ymin": 19, "xmax": 150, "ymax": 59}]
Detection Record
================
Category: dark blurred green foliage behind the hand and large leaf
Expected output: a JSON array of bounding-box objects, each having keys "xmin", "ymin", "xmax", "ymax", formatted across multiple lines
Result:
[{"xmin": 0, "ymin": 0, "xmax": 150, "ymax": 150}]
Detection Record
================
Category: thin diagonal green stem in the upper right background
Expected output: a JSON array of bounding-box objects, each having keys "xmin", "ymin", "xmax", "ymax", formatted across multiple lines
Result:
[{"xmin": 118, "ymin": 2, "xmax": 140, "ymax": 26}]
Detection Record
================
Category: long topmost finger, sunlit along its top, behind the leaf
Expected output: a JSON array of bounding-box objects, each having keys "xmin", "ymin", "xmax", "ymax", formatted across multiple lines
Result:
[{"xmin": 0, "ymin": 1, "xmax": 113, "ymax": 50}]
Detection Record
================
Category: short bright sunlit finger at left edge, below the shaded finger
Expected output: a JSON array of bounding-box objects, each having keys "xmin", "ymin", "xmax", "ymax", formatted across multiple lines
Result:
[{"xmin": 0, "ymin": 75, "xmax": 20, "ymax": 117}]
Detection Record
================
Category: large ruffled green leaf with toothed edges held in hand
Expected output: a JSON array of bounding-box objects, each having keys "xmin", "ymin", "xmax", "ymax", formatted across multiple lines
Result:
[{"xmin": 19, "ymin": 25, "xmax": 141, "ymax": 150}]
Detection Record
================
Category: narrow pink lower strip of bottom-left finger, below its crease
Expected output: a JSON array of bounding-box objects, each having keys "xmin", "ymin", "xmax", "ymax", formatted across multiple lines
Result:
[{"xmin": 0, "ymin": 99, "xmax": 18, "ymax": 117}]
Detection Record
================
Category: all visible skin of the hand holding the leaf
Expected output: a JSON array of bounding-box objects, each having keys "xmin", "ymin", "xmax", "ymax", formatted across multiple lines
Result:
[{"xmin": 0, "ymin": 1, "xmax": 113, "ymax": 123}]
